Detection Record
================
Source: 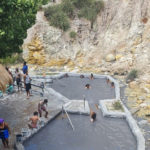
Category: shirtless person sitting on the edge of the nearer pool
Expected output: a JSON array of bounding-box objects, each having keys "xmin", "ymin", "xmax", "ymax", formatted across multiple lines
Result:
[{"xmin": 28, "ymin": 111, "xmax": 39, "ymax": 129}]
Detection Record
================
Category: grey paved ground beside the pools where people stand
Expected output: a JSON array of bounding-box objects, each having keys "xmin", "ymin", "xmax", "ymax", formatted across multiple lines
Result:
[{"xmin": 0, "ymin": 86, "xmax": 62, "ymax": 150}]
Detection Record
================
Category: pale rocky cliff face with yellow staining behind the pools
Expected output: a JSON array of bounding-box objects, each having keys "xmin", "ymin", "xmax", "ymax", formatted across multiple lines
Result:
[{"xmin": 23, "ymin": 0, "xmax": 150, "ymax": 74}]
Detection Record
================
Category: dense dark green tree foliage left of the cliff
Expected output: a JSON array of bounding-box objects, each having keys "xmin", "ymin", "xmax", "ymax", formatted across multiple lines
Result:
[{"xmin": 0, "ymin": 0, "xmax": 48, "ymax": 60}]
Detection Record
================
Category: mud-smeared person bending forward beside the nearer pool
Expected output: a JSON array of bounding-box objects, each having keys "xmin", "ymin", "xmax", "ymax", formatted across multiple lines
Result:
[{"xmin": 38, "ymin": 99, "xmax": 48, "ymax": 118}]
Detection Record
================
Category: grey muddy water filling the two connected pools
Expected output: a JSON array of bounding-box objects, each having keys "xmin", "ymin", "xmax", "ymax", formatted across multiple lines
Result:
[{"xmin": 24, "ymin": 77, "xmax": 136, "ymax": 150}]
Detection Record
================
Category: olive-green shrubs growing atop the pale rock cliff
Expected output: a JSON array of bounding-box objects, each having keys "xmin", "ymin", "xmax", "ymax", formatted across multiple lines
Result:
[{"xmin": 45, "ymin": 0, "xmax": 104, "ymax": 31}]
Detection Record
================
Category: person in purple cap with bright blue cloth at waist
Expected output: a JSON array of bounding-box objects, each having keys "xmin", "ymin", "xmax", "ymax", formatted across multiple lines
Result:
[{"xmin": 0, "ymin": 118, "xmax": 11, "ymax": 148}]
